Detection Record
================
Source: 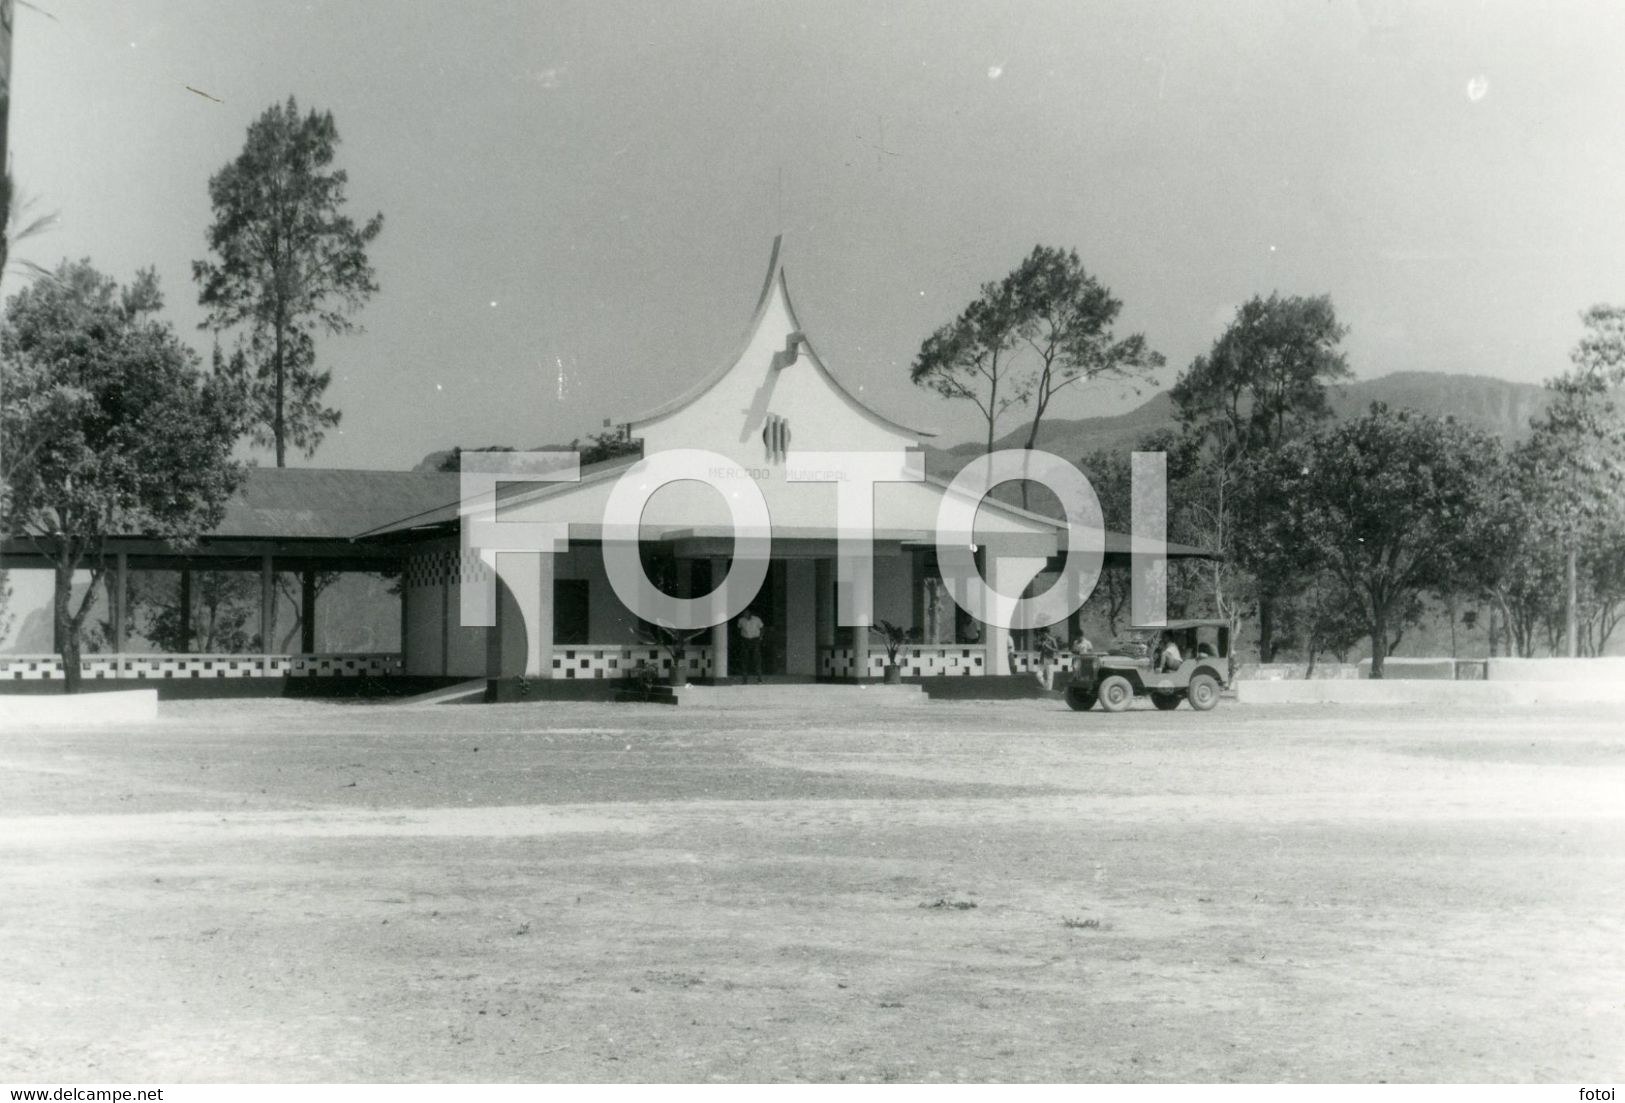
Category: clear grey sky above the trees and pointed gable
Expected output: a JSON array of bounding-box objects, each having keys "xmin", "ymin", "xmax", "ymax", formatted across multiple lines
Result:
[{"xmin": 3, "ymin": 0, "xmax": 1625, "ymax": 468}]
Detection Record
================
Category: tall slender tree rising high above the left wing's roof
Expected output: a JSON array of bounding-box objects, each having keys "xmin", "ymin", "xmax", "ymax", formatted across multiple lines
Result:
[{"xmin": 192, "ymin": 96, "xmax": 384, "ymax": 468}]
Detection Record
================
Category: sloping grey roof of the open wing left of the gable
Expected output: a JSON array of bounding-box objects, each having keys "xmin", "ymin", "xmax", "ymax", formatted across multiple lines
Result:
[{"xmin": 210, "ymin": 468, "xmax": 458, "ymax": 539}]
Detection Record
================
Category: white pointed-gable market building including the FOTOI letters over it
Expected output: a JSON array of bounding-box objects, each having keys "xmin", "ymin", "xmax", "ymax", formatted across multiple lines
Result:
[{"xmin": 0, "ymin": 240, "xmax": 1207, "ymax": 697}]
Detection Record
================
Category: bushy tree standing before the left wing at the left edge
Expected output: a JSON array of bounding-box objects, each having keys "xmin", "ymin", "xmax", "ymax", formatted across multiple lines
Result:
[{"xmin": 0, "ymin": 260, "xmax": 242, "ymax": 692}]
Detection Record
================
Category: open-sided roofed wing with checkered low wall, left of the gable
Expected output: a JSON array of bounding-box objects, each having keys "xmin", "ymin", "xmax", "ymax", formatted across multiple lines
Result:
[{"xmin": 0, "ymin": 468, "xmax": 457, "ymax": 692}]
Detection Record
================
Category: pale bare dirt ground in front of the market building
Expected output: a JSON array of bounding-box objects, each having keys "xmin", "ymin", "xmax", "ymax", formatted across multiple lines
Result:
[{"xmin": 0, "ymin": 700, "xmax": 1625, "ymax": 1084}]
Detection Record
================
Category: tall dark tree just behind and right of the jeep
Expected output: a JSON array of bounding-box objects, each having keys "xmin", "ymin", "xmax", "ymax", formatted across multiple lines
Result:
[{"xmin": 1172, "ymin": 294, "xmax": 1352, "ymax": 663}]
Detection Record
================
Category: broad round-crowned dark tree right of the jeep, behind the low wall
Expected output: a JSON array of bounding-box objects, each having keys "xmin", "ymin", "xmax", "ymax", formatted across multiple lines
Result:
[{"xmin": 1271, "ymin": 403, "xmax": 1500, "ymax": 677}]
